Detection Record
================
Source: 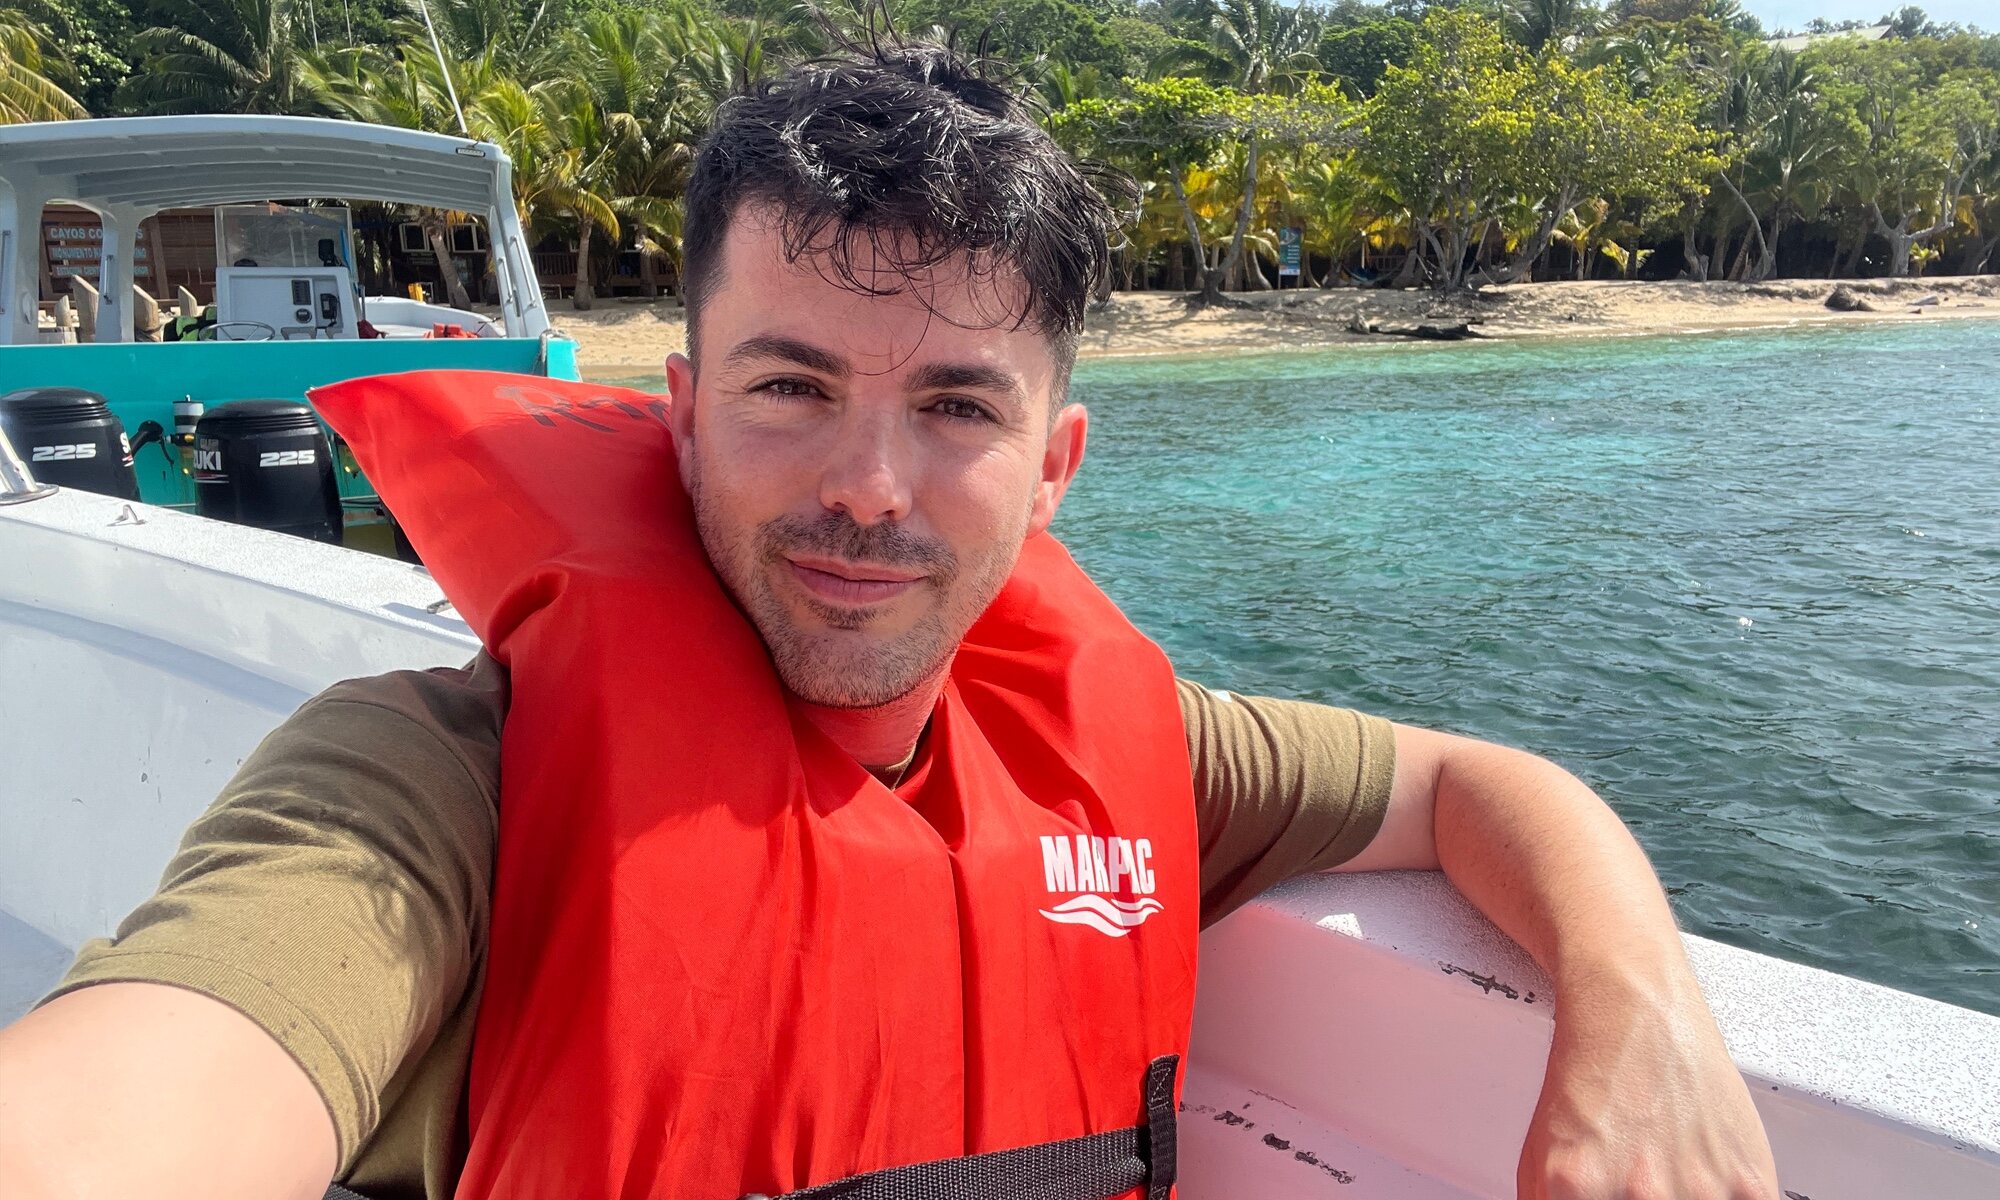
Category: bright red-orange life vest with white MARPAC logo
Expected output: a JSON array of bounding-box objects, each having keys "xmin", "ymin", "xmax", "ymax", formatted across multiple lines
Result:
[{"xmin": 312, "ymin": 372, "xmax": 1198, "ymax": 1200}]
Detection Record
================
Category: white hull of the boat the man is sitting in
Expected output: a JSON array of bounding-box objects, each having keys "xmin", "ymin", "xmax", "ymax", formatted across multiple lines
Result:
[{"xmin": 0, "ymin": 492, "xmax": 2000, "ymax": 1200}]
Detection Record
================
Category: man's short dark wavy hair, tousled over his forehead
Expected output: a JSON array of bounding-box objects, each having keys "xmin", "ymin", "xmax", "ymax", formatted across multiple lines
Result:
[{"xmin": 682, "ymin": 42, "xmax": 1132, "ymax": 380}]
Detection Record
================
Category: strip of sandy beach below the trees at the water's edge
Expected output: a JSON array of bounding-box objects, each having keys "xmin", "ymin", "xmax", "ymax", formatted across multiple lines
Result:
[{"xmin": 550, "ymin": 276, "xmax": 2000, "ymax": 378}]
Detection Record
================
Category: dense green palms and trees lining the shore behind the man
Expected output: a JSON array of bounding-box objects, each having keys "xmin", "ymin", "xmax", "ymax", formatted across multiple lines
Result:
[{"xmin": 19, "ymin": 0, "xmax": 2000, "ymax": 290}]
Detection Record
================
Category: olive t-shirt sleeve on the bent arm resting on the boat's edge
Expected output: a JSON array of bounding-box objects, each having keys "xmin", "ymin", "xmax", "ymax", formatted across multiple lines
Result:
[{"xmin": 1180, "ymin": 680, "xmax": 1396, "ymax": 928}]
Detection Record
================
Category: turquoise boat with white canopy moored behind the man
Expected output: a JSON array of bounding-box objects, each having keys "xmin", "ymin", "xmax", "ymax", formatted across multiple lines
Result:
[{"xmin": 0, "ymin": 116, "xmax": 580, "ymax": 542}]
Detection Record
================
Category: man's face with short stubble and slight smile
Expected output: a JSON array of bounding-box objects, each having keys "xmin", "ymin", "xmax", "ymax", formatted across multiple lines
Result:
[{"xmin": 668, "ymin": 206, "xmax": 1086, "ymax": 708}]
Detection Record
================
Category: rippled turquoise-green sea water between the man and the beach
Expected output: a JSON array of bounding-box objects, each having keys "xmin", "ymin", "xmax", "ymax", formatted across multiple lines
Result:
[{"xmin": 596, "ymin": 320, "xmax": 2000, "ymax": 1014}]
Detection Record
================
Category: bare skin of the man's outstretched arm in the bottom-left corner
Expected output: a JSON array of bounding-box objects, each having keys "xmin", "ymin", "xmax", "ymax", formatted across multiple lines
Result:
[{"xmin": 0, "ymin": 984, "xmax": 336, "ymax": 1200}]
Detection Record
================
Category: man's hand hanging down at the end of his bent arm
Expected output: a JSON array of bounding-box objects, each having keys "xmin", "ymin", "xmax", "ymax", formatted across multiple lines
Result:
[{"xmin": 1516, "ymin": 978, "xmax": 1778, "ymax": 1200}]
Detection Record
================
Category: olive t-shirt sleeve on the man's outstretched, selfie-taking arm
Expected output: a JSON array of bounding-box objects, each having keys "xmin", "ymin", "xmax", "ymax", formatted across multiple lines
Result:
[{"xmin": 50, "ymin": 656, "xmax": 506, "ymax": 1164}]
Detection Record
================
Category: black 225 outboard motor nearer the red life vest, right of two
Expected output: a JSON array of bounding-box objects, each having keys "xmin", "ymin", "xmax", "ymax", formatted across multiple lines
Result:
[{"xmin": 194, "ymin": 400, "xmax": 342, "ymax": 546}]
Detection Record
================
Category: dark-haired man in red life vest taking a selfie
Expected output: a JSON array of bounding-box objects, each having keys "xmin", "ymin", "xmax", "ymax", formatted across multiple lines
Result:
[{"xmin": 0, "ymin": 48, "xmax": 1778, "ymax": 1200}]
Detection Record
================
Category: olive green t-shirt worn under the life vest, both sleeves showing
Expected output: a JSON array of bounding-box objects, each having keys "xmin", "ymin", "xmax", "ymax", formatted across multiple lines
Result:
[{"xmin": 52, "ymin": 654, "xmax": 1394, "ymax": 1200}]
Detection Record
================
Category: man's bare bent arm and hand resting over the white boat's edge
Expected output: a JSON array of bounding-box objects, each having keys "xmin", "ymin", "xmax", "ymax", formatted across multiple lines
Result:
[{"xmin": 1336, "ymin": 726, "xmax": 1778, "ymax": 1200}]
